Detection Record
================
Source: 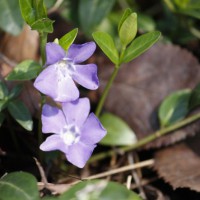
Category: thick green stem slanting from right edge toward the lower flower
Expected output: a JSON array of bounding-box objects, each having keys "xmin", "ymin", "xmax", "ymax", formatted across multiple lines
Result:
[{"xmin": 89, "ymin": 113, "xmax": 200, "ymax": 162}]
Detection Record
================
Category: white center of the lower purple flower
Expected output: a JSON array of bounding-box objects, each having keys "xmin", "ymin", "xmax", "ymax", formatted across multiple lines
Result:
[{"xmin": 60, "ymin": 125, "xmax": 80, "ymax": 145}]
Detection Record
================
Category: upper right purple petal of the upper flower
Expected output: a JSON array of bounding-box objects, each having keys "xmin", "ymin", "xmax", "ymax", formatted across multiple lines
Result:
[{"xmin": 67, "ymin": 42, "xmax": 96, "ymax": 63}]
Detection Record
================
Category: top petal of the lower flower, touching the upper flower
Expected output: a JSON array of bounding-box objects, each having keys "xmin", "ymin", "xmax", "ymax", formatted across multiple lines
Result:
[{"xmin": 62, "ymin": 98, "xmax": 90, "ymax": 128}]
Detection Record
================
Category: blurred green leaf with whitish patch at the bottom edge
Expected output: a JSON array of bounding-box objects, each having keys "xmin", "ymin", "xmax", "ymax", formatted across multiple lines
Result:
[{"xmin": 59, "ymin": 180, "xmax": 142, "ymax": 200}]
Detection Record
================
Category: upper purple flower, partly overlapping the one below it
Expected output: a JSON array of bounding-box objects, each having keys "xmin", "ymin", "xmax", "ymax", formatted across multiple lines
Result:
[{"xmin": 34, "ymin": 42, "xmax": 99, "ymax": 102}]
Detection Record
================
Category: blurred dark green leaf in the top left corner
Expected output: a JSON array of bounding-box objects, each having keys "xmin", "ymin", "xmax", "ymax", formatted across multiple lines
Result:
[{"xmin": 0, "ymin": 0, "xmax": 24, "ymax": 35}]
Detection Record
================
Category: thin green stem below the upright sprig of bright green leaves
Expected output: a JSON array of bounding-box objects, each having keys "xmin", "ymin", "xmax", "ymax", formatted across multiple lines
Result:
[{"xmin": 95, "ymin": 66, "xmax": 119, "ymax": 117}]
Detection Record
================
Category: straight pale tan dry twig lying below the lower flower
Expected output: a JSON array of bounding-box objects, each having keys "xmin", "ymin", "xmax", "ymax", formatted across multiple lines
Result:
[{"xmin": 83, "ymin": 159, "xmax": 154, "ymax": 180}]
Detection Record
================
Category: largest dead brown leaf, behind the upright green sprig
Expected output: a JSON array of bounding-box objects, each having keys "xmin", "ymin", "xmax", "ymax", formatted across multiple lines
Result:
[{"xmin": 99, "ymin": 44, "xmax": 200, "ymax": 147}]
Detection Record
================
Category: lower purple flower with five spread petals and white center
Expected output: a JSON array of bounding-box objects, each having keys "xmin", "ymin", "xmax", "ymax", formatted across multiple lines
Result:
[{"xmin": 40, "ymin": 98, "xmax": 106, "ymax": 168}]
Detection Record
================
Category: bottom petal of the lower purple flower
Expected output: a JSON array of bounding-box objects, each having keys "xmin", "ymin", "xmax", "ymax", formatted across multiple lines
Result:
[{"xmin": 66, "ymin": 142, "xmax": 96, "ymax": 168}]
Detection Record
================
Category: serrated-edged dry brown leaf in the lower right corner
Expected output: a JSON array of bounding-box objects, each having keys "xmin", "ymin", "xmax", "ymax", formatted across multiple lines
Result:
[{"xmin": 154, "ymin": 136, "xmax": 200, "ymax": 192}]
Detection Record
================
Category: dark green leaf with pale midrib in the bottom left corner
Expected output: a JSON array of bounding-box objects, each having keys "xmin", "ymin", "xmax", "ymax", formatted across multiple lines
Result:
[{"xmin": 0, "ymin": 172, "xmax": 40, "ymax": 200}]
